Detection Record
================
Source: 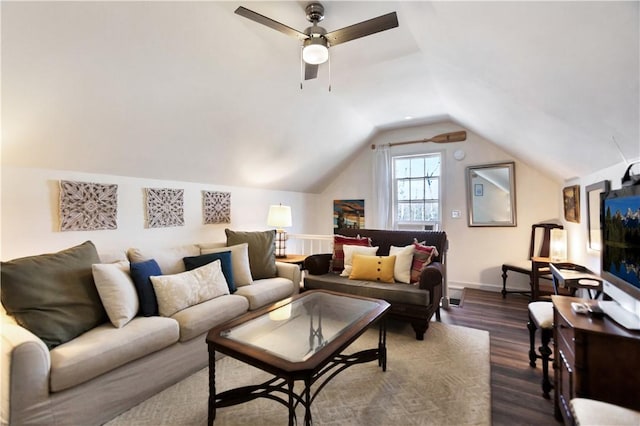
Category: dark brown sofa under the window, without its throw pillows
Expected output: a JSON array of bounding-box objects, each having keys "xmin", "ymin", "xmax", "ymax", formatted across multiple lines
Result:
[{"xmin": 304, "ymin": 229, "xmax": 448, "ymax": 340}]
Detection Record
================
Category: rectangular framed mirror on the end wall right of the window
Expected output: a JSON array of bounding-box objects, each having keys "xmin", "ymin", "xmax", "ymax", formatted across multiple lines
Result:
[{"xmin": 467, "ymin": 162, "xmax": 516, "ymax": 226}]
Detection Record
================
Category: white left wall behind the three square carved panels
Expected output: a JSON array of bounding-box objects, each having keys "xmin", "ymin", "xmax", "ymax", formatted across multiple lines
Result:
[{"xmin": 0, "ymin": 167, "xmax": 313, "ymax": 260}]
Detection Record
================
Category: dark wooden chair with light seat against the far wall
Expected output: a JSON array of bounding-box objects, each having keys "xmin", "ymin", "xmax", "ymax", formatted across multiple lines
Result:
[{"xmin": 502, "ymin": 223, "xmax": 562, "ymax": 301}]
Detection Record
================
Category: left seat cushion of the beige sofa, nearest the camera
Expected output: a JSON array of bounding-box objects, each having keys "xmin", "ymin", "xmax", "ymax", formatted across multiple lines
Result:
[{"xmin": 50, "ymin": 317, "xmax": 180, "ymax": 392}]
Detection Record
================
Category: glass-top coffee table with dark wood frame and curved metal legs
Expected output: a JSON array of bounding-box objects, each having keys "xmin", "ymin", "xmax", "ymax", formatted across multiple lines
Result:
[{"xmin": 207, "ymin": 290, "xmax": 390, "ymax": 425}]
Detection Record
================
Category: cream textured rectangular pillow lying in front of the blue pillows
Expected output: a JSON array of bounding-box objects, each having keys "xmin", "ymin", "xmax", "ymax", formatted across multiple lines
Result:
[{"xmin": 150, "ymin": 260, "xmax": 229, "ymax": 317}]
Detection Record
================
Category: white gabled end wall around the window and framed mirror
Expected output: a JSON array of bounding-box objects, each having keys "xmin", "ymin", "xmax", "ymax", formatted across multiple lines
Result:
[{"xmin": 314, "ymin": 122, "xmax": 562, "ymax": 290}]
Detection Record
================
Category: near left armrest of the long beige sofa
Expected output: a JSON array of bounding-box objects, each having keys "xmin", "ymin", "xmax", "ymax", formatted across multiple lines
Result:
[{"xmin": 0, "ymin": 321, "xmax": 52, "ymax": 424}]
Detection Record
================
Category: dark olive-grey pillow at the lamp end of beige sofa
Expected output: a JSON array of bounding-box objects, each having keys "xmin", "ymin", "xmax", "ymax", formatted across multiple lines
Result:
[{"xmin": 224, "ymin": 229, "xmax": 277, "ymax": 280}]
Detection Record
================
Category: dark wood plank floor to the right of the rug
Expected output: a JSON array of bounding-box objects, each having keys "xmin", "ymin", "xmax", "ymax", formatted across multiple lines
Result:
[{"xmin": 442, "ymin": 289, "xmax": 561, "ymax": 426}]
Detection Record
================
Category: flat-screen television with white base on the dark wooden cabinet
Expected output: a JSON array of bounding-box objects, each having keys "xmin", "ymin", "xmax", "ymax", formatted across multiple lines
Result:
[{"xmin": 599, "ymin": 185, "xmax": 640, "ymax": 330}]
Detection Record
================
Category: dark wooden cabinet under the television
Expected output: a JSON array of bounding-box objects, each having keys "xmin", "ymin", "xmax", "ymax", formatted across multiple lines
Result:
[{"xmin": 551, "ymin": 296, "xmax": 640, "ymax": 424}]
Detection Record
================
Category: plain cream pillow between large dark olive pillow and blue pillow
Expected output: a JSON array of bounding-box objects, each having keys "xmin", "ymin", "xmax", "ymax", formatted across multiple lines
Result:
[{"xmin": 91, "ymin": 261, "xmax": 140, "ymax": 328}]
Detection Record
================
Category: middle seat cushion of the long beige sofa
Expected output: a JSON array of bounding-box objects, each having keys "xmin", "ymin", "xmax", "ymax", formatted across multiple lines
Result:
[{"xmin": 171, "ymin": 294, "xmax": 249, "ymax": 342}]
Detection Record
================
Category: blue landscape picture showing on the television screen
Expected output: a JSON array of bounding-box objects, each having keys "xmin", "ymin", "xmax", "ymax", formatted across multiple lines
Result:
[{"xmin": 602, "ymin": 195, "xmax": 640, "ymax": 288}]
